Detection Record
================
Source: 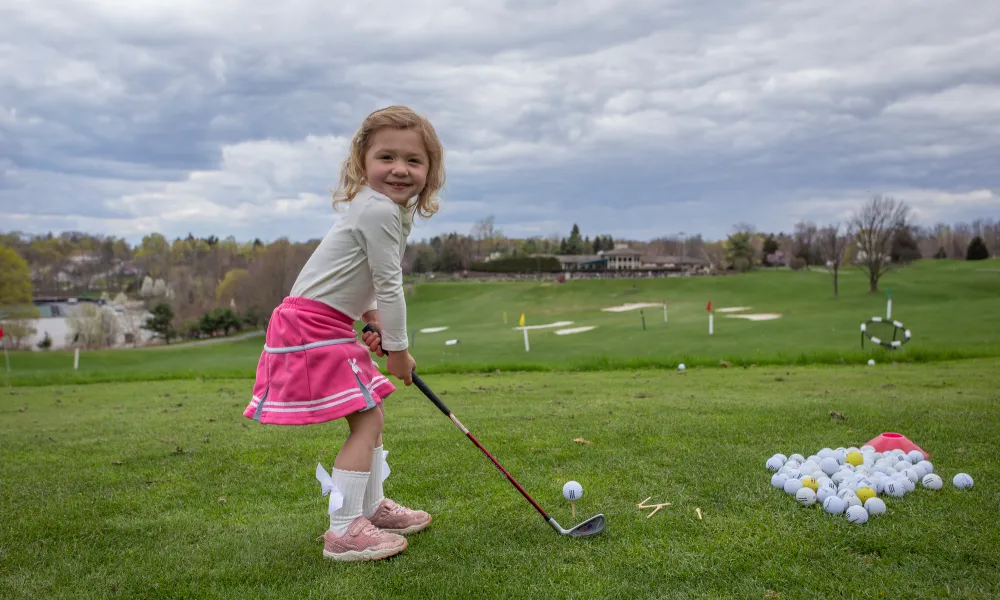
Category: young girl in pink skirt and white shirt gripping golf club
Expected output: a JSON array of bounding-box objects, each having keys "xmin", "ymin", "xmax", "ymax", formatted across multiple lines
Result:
[{"xmin": 243, "ymin": 106, "xmax": 444, "ymax": 561}]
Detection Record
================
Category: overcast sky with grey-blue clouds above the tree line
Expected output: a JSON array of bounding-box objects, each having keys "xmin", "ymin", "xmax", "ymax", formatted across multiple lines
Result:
[{"xmin": 0, "ymin": 0, "xmax": 1000, "ymax": 241}]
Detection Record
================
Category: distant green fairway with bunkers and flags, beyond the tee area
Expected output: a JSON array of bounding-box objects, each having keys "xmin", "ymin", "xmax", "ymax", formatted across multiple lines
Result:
[{"xmin": 11, "ymin": 261, "xmax": 1000, "ymax": 386}]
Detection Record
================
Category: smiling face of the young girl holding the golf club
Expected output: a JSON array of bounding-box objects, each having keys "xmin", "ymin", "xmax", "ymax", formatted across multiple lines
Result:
[{"xmin": 365, "ymin": 127, "xmax": 430, "ymax": 206}]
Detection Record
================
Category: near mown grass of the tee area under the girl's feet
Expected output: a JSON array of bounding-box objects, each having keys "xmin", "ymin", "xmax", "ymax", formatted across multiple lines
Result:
[{"xmin": 0, "ymin": 358, "xmax": 1000, "ymax": 600}]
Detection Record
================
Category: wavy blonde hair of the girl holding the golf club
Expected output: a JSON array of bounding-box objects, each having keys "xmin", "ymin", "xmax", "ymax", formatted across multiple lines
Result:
[{"xmin": 333, "ymin": 106, "xmax": 444, "ymax": 219}]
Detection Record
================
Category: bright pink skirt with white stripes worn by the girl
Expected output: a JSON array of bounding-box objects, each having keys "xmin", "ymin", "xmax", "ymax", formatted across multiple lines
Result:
[{"xmin": 243, "ymin": 297, "xmax": 396, "ymax": 425}]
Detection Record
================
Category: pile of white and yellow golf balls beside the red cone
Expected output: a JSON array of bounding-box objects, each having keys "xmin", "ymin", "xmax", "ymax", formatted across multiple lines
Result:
[{"xmin": 765, "ymin": 445, "xmax": 973, "ymax": 524}]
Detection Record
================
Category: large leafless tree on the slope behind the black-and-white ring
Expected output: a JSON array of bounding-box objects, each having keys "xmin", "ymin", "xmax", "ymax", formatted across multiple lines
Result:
[{"xmin": 848, "ymin": 196, "xmax": 910, "ymax": 292}]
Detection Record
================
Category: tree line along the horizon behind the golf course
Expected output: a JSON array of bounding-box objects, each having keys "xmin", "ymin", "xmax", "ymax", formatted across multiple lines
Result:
[{"xmin": 0, "ymin": 196, "xmax": 1000, "ymax": 346}]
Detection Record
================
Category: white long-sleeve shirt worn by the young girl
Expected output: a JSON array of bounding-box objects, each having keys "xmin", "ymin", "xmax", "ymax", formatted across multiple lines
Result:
[{"xmin": 291, "ymin": 187, "xmax": 413, "ymax": 350}]
